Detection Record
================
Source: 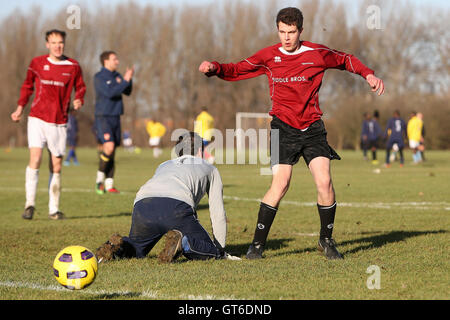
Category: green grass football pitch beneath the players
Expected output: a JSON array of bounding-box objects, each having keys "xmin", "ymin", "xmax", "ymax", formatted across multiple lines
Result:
[{"xmin": 0, "ymin": 148, "xmax": 450, "ymax": 300}]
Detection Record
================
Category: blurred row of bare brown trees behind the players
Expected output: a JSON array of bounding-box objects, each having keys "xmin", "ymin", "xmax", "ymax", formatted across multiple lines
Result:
[{"xmin": 0, "ymin": 0, "xmax": 450, "ymax": 149}]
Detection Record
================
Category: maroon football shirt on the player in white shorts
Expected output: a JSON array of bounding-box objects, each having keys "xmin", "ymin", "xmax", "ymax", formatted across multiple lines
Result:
[{"xmin": 17, "ymin": 55, "xmax": 86, "ymax": 124}]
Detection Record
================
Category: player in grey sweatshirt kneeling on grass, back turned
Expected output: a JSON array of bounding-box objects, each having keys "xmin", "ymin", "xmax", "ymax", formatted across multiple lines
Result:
[{"xmin": 93, "ymin": 132, "xmax": 239, "ymax": 262}]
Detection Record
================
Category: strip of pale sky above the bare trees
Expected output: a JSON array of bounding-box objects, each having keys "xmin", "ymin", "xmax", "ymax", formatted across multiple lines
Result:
[{"xmin": 0, "ymin": 0, "xmax": 450, "ymax": 19}]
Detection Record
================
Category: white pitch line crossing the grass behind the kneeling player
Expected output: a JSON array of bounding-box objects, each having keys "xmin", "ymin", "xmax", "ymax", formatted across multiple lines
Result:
[{"xmin": 0, "ymin": 187, "xmax": 450, "ymax": 211}]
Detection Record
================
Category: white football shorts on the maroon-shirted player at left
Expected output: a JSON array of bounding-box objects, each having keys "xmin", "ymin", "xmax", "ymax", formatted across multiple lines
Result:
[{"xmin": 28, "ymin": 117, "xmax": 67, "ymax": 157}]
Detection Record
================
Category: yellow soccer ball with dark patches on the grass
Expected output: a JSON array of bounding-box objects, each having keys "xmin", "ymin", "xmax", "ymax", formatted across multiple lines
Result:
[{"xmin": 53, "ymin": 246, "xmax": 98, "ymax": 290}]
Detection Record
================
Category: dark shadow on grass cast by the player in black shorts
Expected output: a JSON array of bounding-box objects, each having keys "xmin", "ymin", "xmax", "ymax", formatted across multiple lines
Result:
[{"xmin": 276, "ymin": 230, "xmax": 449, "ymax": 256}]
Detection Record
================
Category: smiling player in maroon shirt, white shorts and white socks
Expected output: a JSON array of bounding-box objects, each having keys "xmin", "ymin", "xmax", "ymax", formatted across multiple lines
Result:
[{"xmin": 11, "ymin": 29, "xmax": 86, "ymax": 220}]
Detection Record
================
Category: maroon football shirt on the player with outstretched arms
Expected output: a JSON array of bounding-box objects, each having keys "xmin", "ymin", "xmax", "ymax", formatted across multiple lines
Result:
[{"xmin": 208, "ymin": 41, "xmax": 374, "ymax": 129}]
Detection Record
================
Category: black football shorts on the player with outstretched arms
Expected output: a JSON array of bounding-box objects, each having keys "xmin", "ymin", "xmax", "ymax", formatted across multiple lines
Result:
[{"xmin": 270, "ymin": 116, "xmax": 341, "ymax": 166}]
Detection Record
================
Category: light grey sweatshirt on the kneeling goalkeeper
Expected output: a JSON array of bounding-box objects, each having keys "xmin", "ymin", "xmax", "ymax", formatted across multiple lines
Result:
[{"xmin": 134, "ymin": 155, "xmax": 227, "ymax": 249}]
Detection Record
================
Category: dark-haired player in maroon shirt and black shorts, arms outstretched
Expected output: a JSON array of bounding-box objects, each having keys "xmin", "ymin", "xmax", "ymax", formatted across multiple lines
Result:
[{"xmin": 199, "ymin": 8, "xmax": 384, "ymax": 259}]
